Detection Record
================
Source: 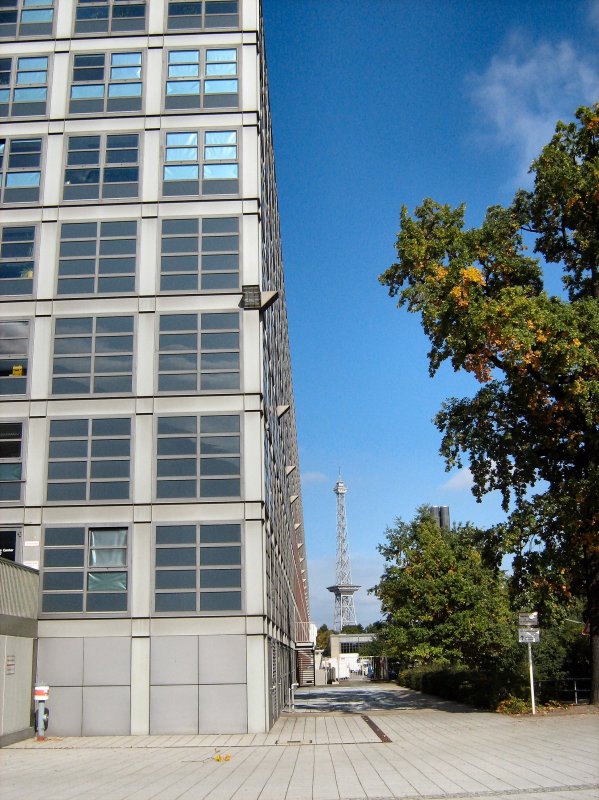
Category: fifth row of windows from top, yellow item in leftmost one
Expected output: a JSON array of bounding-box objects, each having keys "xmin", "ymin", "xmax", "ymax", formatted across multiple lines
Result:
[{"xmin": 0, "ymin": 311, "xmax": 241, "ymax": 397}]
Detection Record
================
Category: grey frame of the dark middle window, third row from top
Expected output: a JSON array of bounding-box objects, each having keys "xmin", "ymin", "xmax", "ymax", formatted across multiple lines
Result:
[{"xmin": 62, "ymin": 131, "xmax": 143, "ymax": 205}]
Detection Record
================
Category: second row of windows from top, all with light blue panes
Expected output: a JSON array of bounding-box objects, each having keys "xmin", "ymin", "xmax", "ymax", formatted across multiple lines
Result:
[{"xmin": 0, "ymin": 48, "xmax": 239, "ymax": 118}]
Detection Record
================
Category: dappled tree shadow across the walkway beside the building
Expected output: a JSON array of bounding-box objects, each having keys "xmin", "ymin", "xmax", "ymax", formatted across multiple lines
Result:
[{"xmin": 290, "ymin": 682, "xmax": 477, "ymax": 714}]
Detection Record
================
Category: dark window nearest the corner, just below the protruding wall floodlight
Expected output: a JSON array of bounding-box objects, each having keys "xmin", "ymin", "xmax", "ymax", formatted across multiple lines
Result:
[{"xmin": 158, "ymin": 312, "xmax": 240, "ymax": 390}]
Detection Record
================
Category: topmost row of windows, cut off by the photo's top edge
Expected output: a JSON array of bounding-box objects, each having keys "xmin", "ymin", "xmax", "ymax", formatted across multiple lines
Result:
[{"xmin": 0, "ymin": 0, "xmax": 239, "ymax": 39}]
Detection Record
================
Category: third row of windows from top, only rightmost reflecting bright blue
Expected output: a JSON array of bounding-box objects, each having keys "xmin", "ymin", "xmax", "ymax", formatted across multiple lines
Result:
[{"xmin": 0, "ymin": 130, "xmax": 239, "ymax": 205}]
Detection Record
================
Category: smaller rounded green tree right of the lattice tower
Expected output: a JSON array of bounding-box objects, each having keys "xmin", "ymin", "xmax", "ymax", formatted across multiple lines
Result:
[{"xmin": 371, "ymin": 507, "xmax": 517, "ymax": 670}]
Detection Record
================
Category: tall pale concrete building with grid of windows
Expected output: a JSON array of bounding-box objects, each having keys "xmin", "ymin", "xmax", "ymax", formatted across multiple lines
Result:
[{"xmin": 0, "ymin": 0, "xmax": 309, "ymax": 735}]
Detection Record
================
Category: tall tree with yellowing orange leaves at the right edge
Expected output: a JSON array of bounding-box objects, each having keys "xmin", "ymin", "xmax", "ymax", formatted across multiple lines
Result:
[{"xmin": 380, "ymin": 105, "xmax": 599, "ymax": 703}]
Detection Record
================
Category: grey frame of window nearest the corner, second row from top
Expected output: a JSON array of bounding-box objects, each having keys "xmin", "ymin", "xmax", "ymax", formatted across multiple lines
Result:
[{"xmin": 162, "ymin": 45, "xmax": 241, "ymax": 114}]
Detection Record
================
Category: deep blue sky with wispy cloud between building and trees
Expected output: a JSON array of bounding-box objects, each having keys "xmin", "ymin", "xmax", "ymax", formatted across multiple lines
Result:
[{"xmin": 263, "ymin": 0, "xmax": 599, "ymax": 625}]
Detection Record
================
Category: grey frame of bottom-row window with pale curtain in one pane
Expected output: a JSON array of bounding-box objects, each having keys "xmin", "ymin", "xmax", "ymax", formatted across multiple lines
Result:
[{"xmin": 39, "ymin": 522, "xmax": 133, "ymax": 618}]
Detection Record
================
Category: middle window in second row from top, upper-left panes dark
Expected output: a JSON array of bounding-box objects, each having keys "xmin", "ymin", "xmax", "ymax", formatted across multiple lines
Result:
[{"xmin": 69, "ymin": 51, "xmax": 142, "ymax": 114}]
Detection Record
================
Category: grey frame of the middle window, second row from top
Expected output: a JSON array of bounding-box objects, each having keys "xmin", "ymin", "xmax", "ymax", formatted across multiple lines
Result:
[{"xmin": 67, "ymin": 48, "xmax": 145, "ymax": 118}]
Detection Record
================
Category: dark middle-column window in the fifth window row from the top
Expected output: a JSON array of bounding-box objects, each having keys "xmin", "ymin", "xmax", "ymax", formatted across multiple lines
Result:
[{"xmin": 52, "ymin": 316, "xmax": 134, "ymax": 395}]
